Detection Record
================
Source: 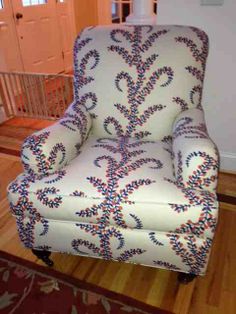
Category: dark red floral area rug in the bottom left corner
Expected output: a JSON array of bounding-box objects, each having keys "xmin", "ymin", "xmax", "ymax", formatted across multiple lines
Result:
[{"xmin": 0, "ymin": 251, "xmax": 170, "ymax": 314}]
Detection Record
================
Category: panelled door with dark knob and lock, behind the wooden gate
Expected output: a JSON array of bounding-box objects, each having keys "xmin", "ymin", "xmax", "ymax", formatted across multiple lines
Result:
[{"xmin": 12, "ymin": 0, "xmax": 64, "ymax": 73}]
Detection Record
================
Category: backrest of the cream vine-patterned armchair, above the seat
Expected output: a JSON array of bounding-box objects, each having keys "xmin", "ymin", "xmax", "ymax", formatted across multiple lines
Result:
[{"xmin": 74, "ymin": 24, "xmax": 208, "ymax": 140}]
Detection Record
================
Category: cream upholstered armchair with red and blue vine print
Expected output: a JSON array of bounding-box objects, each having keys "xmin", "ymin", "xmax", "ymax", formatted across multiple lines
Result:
[{"xmin": 8, "ymin": 25, "xmax": 218, "ymax": 279}]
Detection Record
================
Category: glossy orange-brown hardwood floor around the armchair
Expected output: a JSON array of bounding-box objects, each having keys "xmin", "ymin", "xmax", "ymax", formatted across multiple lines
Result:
[{"xmin": 0, "ymin": 119, "xmax": 236, "ymax": 314}]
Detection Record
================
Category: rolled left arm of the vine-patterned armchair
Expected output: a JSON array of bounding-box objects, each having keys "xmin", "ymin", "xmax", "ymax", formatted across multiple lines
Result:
[{"xmin": 21, "ymin": 102, "xmax": 91, "ymax": 176}]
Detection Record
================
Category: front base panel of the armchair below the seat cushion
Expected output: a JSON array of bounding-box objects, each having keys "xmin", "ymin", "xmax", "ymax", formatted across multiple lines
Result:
[{"xmin": 16, "ymin": 216, "xmax": 212, "ymax": 275}]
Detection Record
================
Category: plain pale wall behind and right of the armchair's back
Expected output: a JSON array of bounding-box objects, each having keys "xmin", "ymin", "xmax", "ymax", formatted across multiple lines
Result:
[{"xmin": 157, "ymin": 0, "xmax": 236, "ymax": 171}]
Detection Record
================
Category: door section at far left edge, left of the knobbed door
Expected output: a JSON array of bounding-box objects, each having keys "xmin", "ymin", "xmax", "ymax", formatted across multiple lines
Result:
[{"xmin": 0, "ymin": 0, "xmax": 23, "ymax": 71}]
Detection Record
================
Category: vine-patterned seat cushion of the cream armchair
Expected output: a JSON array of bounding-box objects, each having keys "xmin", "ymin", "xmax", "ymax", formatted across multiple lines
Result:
[{"xmin": 9, "ymin": 136, "xmax": 217, "ymax": 237}]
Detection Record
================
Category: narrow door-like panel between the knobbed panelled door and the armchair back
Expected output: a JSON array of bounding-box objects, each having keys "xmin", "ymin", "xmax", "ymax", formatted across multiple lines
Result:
[{"xmin": 56, "ymin": 0, "xmax": 76, "ymax": 72}]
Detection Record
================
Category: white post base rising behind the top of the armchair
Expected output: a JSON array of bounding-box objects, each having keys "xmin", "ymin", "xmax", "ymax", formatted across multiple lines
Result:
[{"xmin": 126, "ymin": 0, "xmax": 157, "ymax": 25}]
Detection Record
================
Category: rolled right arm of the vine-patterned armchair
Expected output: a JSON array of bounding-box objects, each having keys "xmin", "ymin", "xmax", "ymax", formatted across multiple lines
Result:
[{"xmin": 173, "ymin": 108, "xmax": 219, "ymax": 192}]
